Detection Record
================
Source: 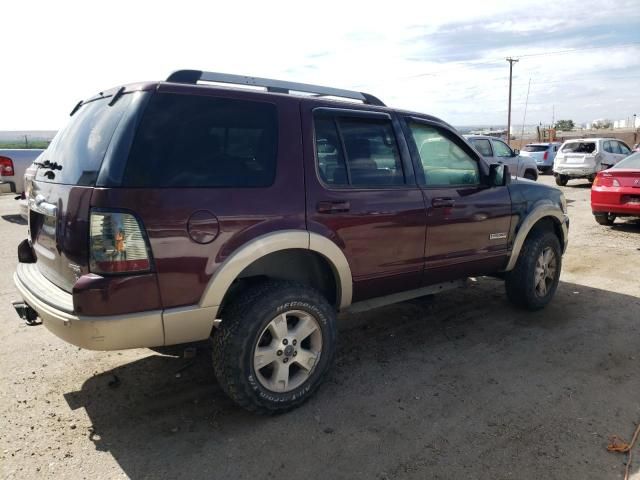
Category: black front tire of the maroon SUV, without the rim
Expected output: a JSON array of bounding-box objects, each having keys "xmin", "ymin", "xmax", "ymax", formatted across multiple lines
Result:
[{"xmin": 505, "ymin": 228, "xmax": 562, "ymax": 310}]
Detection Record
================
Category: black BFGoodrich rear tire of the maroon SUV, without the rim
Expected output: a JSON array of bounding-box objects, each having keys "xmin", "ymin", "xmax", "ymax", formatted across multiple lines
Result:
[{"xmin": 211, "ymin": 280, "xmax": 337, "ymax": 415}]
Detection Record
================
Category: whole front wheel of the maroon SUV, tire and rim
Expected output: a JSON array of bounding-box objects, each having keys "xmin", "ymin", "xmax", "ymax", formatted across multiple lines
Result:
[{"xmin": 505, "ymin": 230, "xmax": 562, "ymax": 310}]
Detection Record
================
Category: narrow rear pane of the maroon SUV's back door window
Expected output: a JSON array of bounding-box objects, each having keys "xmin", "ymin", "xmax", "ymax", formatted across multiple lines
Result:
[{"xmin": 315, "ymin": 117, "xmax": 349, "ymax": 185}]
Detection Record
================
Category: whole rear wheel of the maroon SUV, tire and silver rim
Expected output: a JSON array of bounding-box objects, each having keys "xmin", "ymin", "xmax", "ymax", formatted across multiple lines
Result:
[{"xmin": 212, "ymin": 281, "xmax": 336, "ymax": 414}]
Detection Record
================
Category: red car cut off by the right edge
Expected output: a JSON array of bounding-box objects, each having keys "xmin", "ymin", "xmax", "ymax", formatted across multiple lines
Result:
[{"xmin": 591, "ymin": 153, "xmax": 640, "ymax": 225}]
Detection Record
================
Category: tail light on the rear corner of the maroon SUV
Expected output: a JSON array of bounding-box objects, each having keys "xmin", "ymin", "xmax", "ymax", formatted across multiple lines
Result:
[{"xmin": 89, "ymin": 210, "xmax": 151, "ymax": 273}]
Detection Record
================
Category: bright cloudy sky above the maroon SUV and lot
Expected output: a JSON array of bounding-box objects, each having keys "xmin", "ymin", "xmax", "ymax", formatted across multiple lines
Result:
[{"xmin": 0, "ymin": 0, "xmax": 640, "ymax": 130}]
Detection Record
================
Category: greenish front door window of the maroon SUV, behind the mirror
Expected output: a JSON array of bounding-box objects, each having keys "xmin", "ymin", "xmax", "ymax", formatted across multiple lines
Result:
[{"xmin": 409, "ymin": 123, "xmax": 480, "ymax": 186}]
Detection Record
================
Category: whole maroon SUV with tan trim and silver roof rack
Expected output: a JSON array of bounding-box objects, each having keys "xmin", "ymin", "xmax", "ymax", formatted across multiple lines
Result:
[{"xmin": 14, "ymin": 70, "xmax": 569, "ymax": 413}]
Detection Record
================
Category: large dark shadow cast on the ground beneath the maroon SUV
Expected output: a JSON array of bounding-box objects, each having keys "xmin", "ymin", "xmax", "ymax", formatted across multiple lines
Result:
[{"xmin": 65, "ymin": 279, "xmax": 640, "ymax": 479}]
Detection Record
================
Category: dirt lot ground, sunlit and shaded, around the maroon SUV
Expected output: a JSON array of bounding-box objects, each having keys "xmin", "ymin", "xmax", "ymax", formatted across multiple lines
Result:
[{"xmin": 0, "ymin": 176, "xmax": 640, "ymax": 479}]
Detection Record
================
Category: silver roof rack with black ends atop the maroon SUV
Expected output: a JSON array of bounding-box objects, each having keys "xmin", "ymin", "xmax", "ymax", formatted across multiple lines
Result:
[{"xmin": 167, "ymin": 70, "xmax": 386, "ymax": 107}]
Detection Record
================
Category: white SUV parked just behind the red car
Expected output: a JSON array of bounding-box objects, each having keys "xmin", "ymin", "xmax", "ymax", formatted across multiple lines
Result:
[{"xmin": 553, "ymin": 138, "xmax": 631, "ymax": 186}]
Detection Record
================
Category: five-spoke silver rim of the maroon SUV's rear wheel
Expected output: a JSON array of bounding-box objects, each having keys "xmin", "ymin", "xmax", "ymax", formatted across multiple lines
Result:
[{"xmin": 253, "ymin": 310, "xmax": 322, "ymax": 393}]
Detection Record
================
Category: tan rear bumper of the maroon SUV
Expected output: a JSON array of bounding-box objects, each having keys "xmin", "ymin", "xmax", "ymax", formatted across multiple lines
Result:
[{"xmin": 13, "ymin": 263, "xmax": 164, "ymax": 350}]
